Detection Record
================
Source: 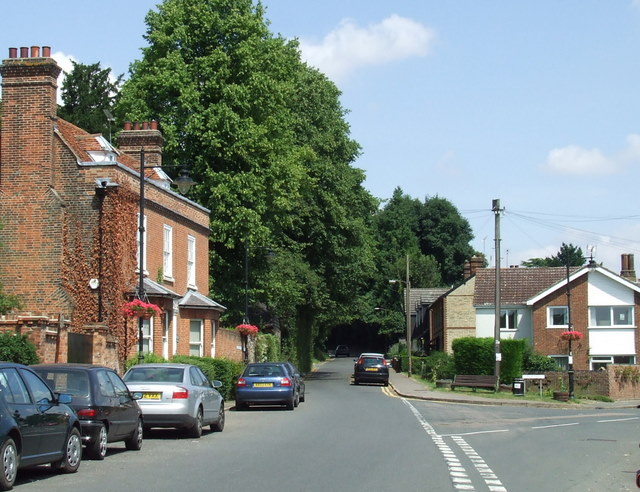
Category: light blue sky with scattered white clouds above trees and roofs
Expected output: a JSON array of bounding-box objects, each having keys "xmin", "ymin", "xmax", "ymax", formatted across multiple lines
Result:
[{"xmin": 0, "ymin": 0, "xmax": 640, "ymax": 273}]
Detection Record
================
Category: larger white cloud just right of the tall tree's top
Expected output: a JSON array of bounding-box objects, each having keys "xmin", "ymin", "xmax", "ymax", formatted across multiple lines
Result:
[{"xmin": 300, "ymin": 14, "xmax": 436, "ymax": 80}]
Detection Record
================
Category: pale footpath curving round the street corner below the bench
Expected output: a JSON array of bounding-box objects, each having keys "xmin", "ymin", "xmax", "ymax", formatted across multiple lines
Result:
[{"xmin": 389, "ymin": 369, "xmax": 640, "ymax": 409}]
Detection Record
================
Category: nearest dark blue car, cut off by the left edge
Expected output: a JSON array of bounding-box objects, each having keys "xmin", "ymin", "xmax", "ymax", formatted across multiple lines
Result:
[{"xmin": 0, "ymin": 362, "xmax": 82, "ymax": 490}]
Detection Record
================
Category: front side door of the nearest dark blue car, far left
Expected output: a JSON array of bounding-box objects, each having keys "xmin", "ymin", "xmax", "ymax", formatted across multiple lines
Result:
[{"xmin": 18, "ymin": 368, "xmax": 70, "ymax": 458}]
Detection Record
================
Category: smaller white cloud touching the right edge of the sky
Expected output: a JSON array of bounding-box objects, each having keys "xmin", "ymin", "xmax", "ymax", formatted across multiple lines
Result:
[{"xmin": 542, "ymin": 135, "xmax": 640, "ymax": 176}]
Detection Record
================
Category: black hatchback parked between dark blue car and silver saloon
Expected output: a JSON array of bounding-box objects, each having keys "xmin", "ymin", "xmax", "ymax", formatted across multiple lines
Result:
[{"xmin": 31, "ymin": 364, "xmax": 143, "ymax": 460}]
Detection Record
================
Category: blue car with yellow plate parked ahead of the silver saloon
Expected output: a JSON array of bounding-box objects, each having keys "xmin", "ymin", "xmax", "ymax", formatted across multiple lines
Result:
[{"xmin": 236, "ymin": 362, "xmax": 300, "ymax": 410}]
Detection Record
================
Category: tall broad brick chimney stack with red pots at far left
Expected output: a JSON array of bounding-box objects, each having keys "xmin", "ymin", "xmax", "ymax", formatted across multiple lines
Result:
[{"xmin": 0, "ymin": 46, "xmax": 61, "ymax": 187}]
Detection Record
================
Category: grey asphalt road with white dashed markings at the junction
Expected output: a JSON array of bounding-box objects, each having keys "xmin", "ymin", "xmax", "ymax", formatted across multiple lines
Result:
[{"xmin": 11, "ymin": 358, "xmax": 640, "ymax": 492}]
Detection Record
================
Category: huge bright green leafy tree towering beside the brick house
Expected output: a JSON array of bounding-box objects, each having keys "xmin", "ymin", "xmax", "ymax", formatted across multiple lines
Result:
[{"xmin": 117, "ymin": 0, "xmax": 375, "ymax": 369}]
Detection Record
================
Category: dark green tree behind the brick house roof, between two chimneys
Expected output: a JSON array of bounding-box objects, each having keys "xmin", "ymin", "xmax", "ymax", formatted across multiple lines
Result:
[{"xmin": 58, "ymin": 62, "xmax": 123, "ymax": 135}]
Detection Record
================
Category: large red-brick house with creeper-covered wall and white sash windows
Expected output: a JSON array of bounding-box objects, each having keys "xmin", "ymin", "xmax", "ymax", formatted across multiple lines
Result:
[{"xmin": 0, "ymin": 47, "xmax": 241, "ymax": 366}]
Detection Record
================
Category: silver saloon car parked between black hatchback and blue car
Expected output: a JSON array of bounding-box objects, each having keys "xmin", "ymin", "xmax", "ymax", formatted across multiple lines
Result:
[{"xmin": 123, "ymin": 364, "xmax": 225, "ymax": 438}]
